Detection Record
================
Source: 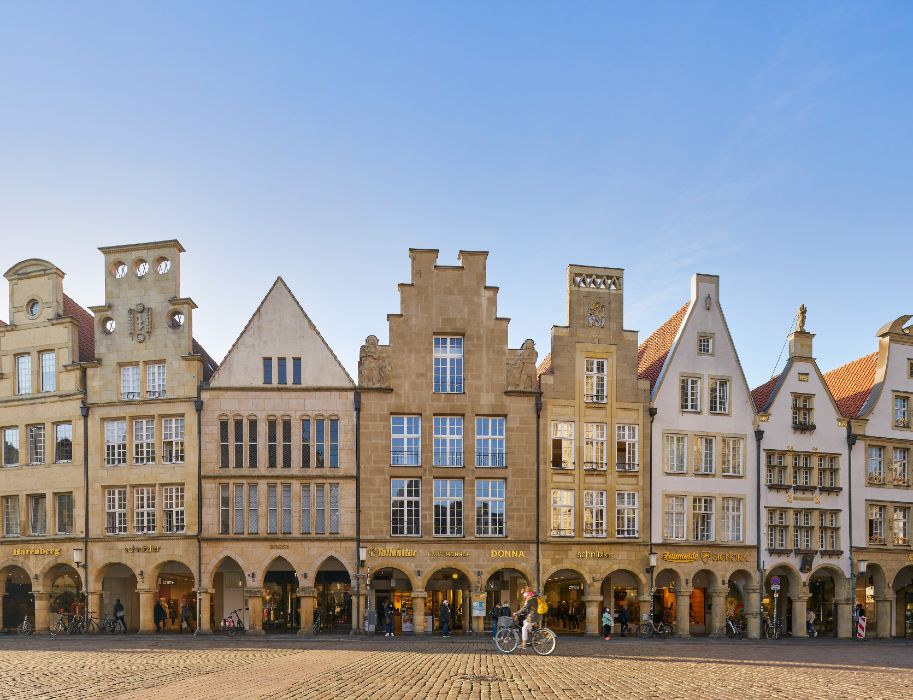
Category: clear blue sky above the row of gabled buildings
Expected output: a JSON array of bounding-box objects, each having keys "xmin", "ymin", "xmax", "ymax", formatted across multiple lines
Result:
[{"xmin": 0, "ymin": 2, "xmax": 913, "ymax": 386}]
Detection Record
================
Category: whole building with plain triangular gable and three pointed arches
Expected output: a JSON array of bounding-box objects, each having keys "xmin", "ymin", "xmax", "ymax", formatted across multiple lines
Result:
[{"xmin": 201, "ymin": 277, "xmax": 359, "ymax": 633}]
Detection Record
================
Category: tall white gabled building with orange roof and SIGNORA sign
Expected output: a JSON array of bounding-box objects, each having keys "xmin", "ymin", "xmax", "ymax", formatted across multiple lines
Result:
[{"xmin": 638, "ymin": 274, "xmax": 760, "ymax": 637}]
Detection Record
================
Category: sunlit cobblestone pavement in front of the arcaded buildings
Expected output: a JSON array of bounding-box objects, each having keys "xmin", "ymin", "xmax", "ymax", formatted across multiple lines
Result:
[{"xmin": 0, "ymin": 636, "xmax": 913, "ymax": 700}]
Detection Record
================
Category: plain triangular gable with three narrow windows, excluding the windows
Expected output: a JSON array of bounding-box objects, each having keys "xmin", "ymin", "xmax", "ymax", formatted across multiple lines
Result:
[{"xmin": 210, "ymin": 277, "xmax": 355, "ymax": 389}]
